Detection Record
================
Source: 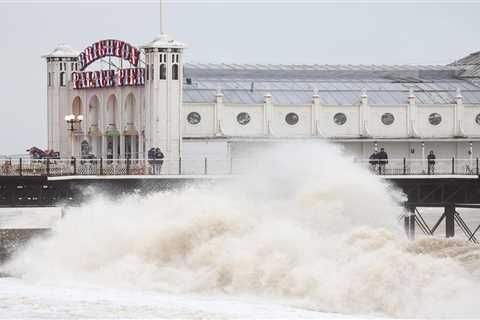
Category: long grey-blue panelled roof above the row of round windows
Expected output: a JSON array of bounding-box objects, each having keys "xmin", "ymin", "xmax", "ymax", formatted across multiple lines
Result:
[{"xmin": 184, "ymin": 63, "xmax": 480, "ymax": 105}]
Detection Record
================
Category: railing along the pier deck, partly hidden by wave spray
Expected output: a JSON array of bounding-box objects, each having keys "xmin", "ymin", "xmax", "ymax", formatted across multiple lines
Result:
[{"xmin": 0, "ymin": 158, "xmax": 479, "ymax": 176}]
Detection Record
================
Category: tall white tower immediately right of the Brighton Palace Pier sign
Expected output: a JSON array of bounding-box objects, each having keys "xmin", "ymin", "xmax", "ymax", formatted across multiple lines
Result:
[{"xmin": 142, "ymin": 34, "xmax": 185, "ymax": 174}]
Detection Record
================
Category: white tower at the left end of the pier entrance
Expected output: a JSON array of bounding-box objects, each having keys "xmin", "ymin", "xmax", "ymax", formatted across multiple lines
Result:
[{"xmin": 43, "ymin": 44, "xmax": 78, "ymax": 156}]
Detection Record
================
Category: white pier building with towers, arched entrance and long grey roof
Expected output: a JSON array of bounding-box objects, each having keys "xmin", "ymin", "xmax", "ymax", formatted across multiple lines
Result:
[{"xmin": 44, "ymin": 34, "xmax": 480, "ymax": 172}]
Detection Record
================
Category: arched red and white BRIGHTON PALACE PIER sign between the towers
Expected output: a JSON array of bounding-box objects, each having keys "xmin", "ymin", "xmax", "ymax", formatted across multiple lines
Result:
[{"xmin": 72, "ymin": 40, "xmax": 145, "ymax": 89}]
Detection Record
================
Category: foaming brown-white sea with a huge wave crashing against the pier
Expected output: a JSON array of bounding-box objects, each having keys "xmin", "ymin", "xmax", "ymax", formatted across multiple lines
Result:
[{"xmin": 0, "ymin": 143, "xmax": 480, "ymax": 318}]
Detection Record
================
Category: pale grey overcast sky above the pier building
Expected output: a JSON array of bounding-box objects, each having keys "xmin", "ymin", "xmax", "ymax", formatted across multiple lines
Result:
[{"xmin": 0, "ymin": 0, "xmax": 480, "ymax": 154}]
